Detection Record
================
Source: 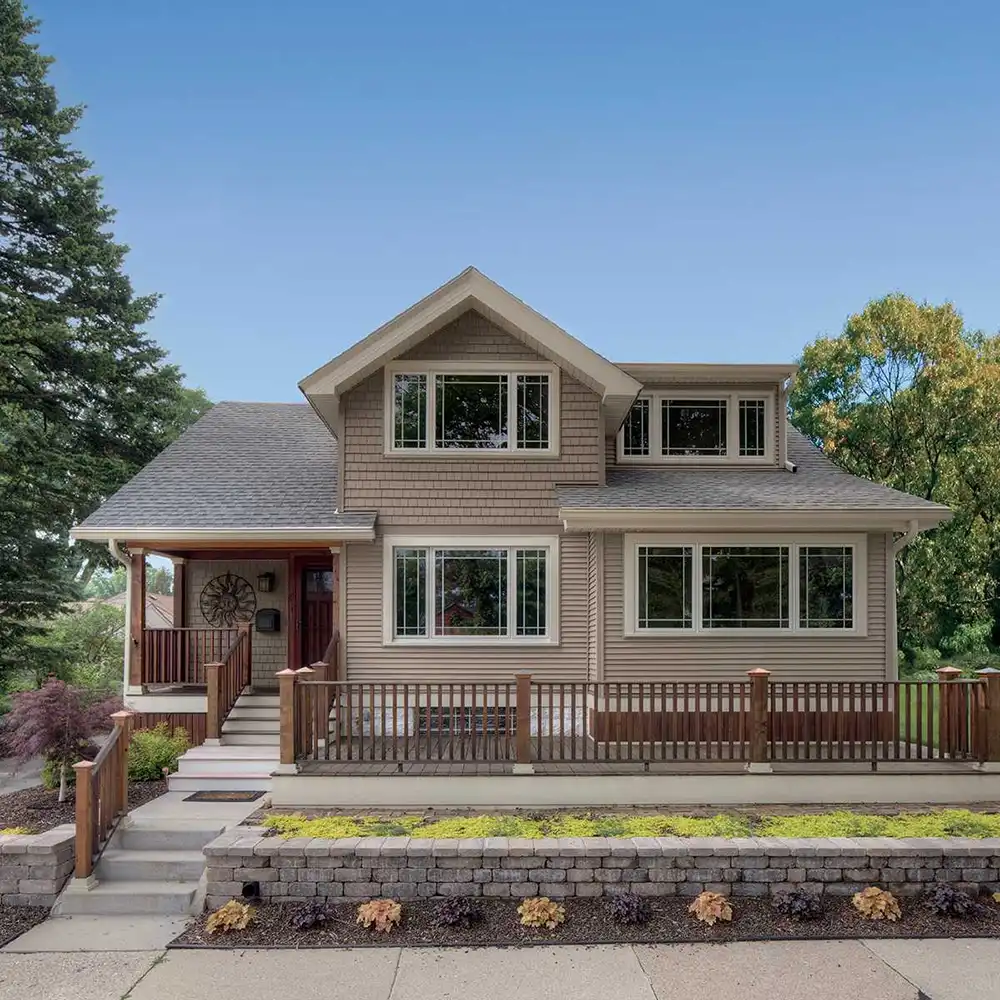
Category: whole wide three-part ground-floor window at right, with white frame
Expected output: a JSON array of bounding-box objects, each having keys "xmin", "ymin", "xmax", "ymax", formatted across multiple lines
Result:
[{"xmin": 625, "ymin": 535, "xmax": 866, "ymax": 635}]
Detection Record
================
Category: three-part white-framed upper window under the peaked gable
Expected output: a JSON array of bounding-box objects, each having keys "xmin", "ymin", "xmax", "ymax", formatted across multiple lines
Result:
[{"xmin": 386, "ymin": 363, "xmax": 558, "ymax": 454}]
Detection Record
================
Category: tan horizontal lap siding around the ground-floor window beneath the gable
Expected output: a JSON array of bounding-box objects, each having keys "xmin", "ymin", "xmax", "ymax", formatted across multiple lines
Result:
[{"xmin": 345, "ymin": 535, "xmax": 588, "ymax": 682}]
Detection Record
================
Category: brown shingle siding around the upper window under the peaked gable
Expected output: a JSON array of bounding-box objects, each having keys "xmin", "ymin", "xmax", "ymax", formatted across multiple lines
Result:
[{"xmin": 342, "ymin": 312, "xmax": 603, "ymax": 529}]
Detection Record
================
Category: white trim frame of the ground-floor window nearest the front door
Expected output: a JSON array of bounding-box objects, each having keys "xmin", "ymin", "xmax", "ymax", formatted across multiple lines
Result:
[{"xmin": 382, "ymin": 535, "xmax": 559, "ymax": 648}]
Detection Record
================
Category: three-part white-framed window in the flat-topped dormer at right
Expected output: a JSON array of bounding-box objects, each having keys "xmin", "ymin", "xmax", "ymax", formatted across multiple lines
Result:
[{"xmin": 618, "ymin": 390, "xmax": 774, "ymax": 463}]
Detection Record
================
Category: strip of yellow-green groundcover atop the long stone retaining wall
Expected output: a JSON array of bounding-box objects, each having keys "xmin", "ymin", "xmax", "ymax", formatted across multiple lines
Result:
[{"xmin": 263, "ymin": 809, "xmax": 1000, "ymax": 839}]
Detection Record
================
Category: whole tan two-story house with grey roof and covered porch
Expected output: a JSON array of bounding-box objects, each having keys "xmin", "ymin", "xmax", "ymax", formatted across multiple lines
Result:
[{"xmin": 74, "ymin": 268, "xmax": 949, "ymax": 783}]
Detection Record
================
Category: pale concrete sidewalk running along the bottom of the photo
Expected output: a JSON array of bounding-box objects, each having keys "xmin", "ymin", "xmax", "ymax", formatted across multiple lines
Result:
[{"xmin": 0, "ymin": 927, "xmax": 1000, "ymax": 1000}]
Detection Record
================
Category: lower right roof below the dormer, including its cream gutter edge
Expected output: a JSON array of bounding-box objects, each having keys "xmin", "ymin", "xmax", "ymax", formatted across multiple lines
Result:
[{"xmin": 558, "ymin": 425, "xmax": 951, "ymax": 530}]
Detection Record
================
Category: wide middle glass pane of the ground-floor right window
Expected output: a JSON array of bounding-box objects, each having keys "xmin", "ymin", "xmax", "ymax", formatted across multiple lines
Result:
[{"xmin": 701, "ymin": 545, "xmax": 788, "ymax": 628}]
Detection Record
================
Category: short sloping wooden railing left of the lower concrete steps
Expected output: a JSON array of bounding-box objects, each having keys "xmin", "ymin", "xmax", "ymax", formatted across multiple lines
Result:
[{"xmin": 73, "ymin": 712, "xmax": 132, "ymax": 878}]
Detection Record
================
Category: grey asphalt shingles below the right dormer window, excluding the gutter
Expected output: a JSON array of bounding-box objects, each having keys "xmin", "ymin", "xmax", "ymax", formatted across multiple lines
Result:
[{"xmin": 559, "ymin": 426, "xmax": 944, "ymax": 512}]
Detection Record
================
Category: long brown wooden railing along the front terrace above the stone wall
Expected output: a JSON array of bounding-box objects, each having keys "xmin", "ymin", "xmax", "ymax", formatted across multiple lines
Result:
[{"xmin": 278, "ymin": 664, "xmax": 1000, "ymax": 771}]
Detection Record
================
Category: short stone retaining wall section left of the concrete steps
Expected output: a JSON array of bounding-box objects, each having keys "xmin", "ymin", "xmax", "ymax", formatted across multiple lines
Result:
[{"xmin": 0, "ymin": 823, "xmax": 76, "ymax": 907}]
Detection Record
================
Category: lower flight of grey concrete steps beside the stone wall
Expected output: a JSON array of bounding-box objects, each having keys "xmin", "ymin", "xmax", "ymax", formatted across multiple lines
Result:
[{"xmin": 52, "ymin": 817, "xmax": 225, "ymax": 916}]
